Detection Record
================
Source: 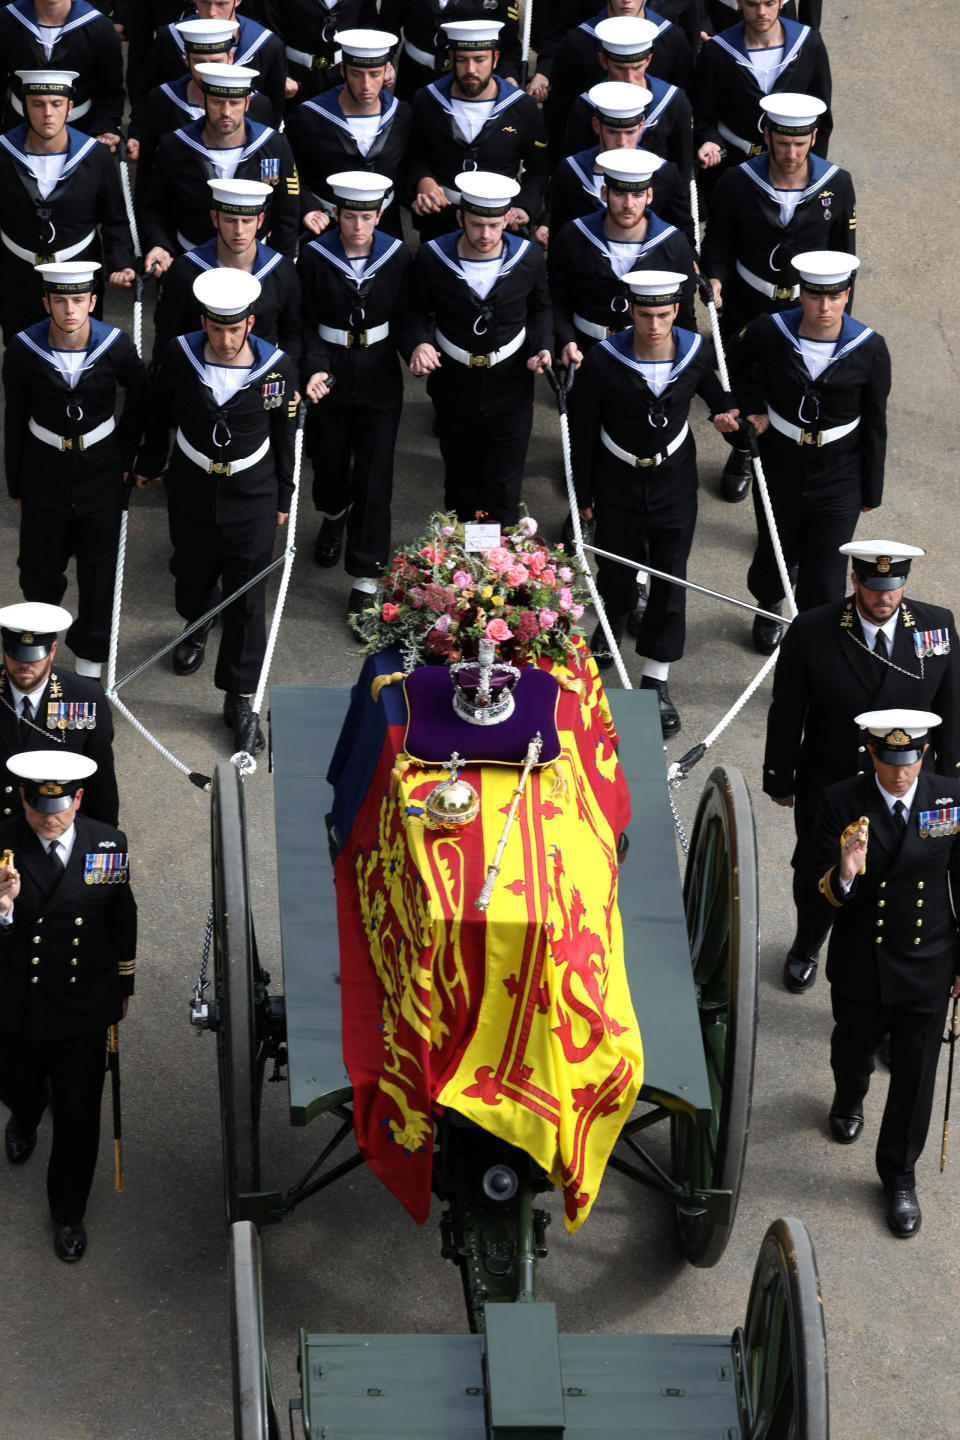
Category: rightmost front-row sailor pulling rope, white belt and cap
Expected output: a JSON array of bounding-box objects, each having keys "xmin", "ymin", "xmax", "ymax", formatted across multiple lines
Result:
[{"xmin": 728, "ymin": 250, "xmax": 889, "ymax": 655}]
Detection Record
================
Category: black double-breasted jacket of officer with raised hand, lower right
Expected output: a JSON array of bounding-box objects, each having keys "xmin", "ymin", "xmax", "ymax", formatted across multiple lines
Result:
[{"xmin": 807, "ymin": 766, "xmax": 960, "ymax": 1007}]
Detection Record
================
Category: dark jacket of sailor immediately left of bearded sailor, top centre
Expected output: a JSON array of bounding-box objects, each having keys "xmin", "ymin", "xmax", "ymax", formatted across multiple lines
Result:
[{"xmin": 285, "ymin": 85, "xmax": 410, "ymax": 236}]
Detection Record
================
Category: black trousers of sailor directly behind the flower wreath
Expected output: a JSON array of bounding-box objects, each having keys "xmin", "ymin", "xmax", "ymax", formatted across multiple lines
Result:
[{"xmin": 436, "ymin": 403, "xmax": 534, "ymax": 526}]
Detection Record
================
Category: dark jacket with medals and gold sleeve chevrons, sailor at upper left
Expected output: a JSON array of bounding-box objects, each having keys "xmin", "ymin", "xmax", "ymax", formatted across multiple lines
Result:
[{"xmin": 140, "ymin": 120, "xmax": 301, "ymax": 255}]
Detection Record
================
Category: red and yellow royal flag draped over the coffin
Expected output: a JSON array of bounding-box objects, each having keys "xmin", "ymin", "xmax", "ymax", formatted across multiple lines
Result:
[{"xmin": 332, "ymin": 657, "xmax": 643, "ymax": 1230}]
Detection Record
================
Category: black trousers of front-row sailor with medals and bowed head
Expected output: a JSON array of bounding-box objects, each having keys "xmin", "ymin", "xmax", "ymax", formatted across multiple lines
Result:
[{"xmin": 168, "ymin": 497, "xmax": 276, "ymax": 696}]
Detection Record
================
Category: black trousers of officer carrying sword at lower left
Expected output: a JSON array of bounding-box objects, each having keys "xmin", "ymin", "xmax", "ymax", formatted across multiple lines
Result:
[{"xmin": 0, "ymin": 1030, "xmax": 107, "ymax": 1225}]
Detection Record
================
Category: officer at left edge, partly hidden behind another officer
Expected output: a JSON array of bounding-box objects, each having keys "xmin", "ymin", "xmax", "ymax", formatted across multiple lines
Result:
[{"xmin": 0, "ymin": 600, "xmax": 119, "ymax": 825}]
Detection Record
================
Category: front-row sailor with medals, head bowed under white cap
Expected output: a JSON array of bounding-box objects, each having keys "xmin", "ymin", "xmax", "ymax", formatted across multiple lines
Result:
[{"xmin": 137, "ymin": 269, "xmax": 298, "ymax": 750}]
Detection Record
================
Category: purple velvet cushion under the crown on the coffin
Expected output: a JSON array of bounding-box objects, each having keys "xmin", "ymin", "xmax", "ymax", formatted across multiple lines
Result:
[{"xmin": 403, "ymin": 665, "xmax": 560, "ymax": 765}]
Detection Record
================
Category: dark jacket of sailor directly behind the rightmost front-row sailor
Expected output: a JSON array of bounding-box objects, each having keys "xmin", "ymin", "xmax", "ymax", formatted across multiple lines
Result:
[{"xmin": 701, "ymin": 154, "xmax": 856, "ymax": 323}]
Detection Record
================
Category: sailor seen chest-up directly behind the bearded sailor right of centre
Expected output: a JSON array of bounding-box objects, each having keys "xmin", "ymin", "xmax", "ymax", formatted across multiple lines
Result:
[{"xmin": 546, "ymin": 81, "xmax": 694, "ymax": 245}]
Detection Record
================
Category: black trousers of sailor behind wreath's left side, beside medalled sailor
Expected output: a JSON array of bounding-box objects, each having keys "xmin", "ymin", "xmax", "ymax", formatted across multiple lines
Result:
[{"xmin": 307, "ymin": 395, "xmax": 403, "ymax": 577}]
